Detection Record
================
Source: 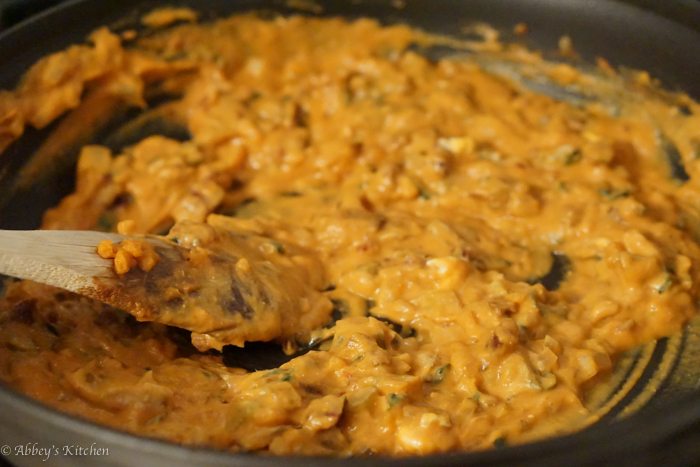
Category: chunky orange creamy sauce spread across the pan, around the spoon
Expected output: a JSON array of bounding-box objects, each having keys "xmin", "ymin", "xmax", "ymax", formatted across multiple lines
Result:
[{"xmin": 0, "ymin": 11, "xmax": 700, "ymax": 455}]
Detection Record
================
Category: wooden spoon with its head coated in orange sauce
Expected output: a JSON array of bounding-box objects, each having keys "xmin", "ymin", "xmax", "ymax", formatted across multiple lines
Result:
[{"xmin": 0, "ymin": 230, "xmax": 332, "ymax": 350}]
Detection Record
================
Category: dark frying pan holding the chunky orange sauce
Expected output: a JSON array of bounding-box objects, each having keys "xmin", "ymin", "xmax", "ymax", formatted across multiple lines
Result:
[{"xmin": 0, "ymin": 0, "xmax": 700, "ymax": 467}]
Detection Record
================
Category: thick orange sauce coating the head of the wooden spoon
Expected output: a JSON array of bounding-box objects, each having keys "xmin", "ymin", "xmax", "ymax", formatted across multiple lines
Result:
[{"xmin": 95, "ymin": 219, "xmax": 332, "ymax": 351}]
